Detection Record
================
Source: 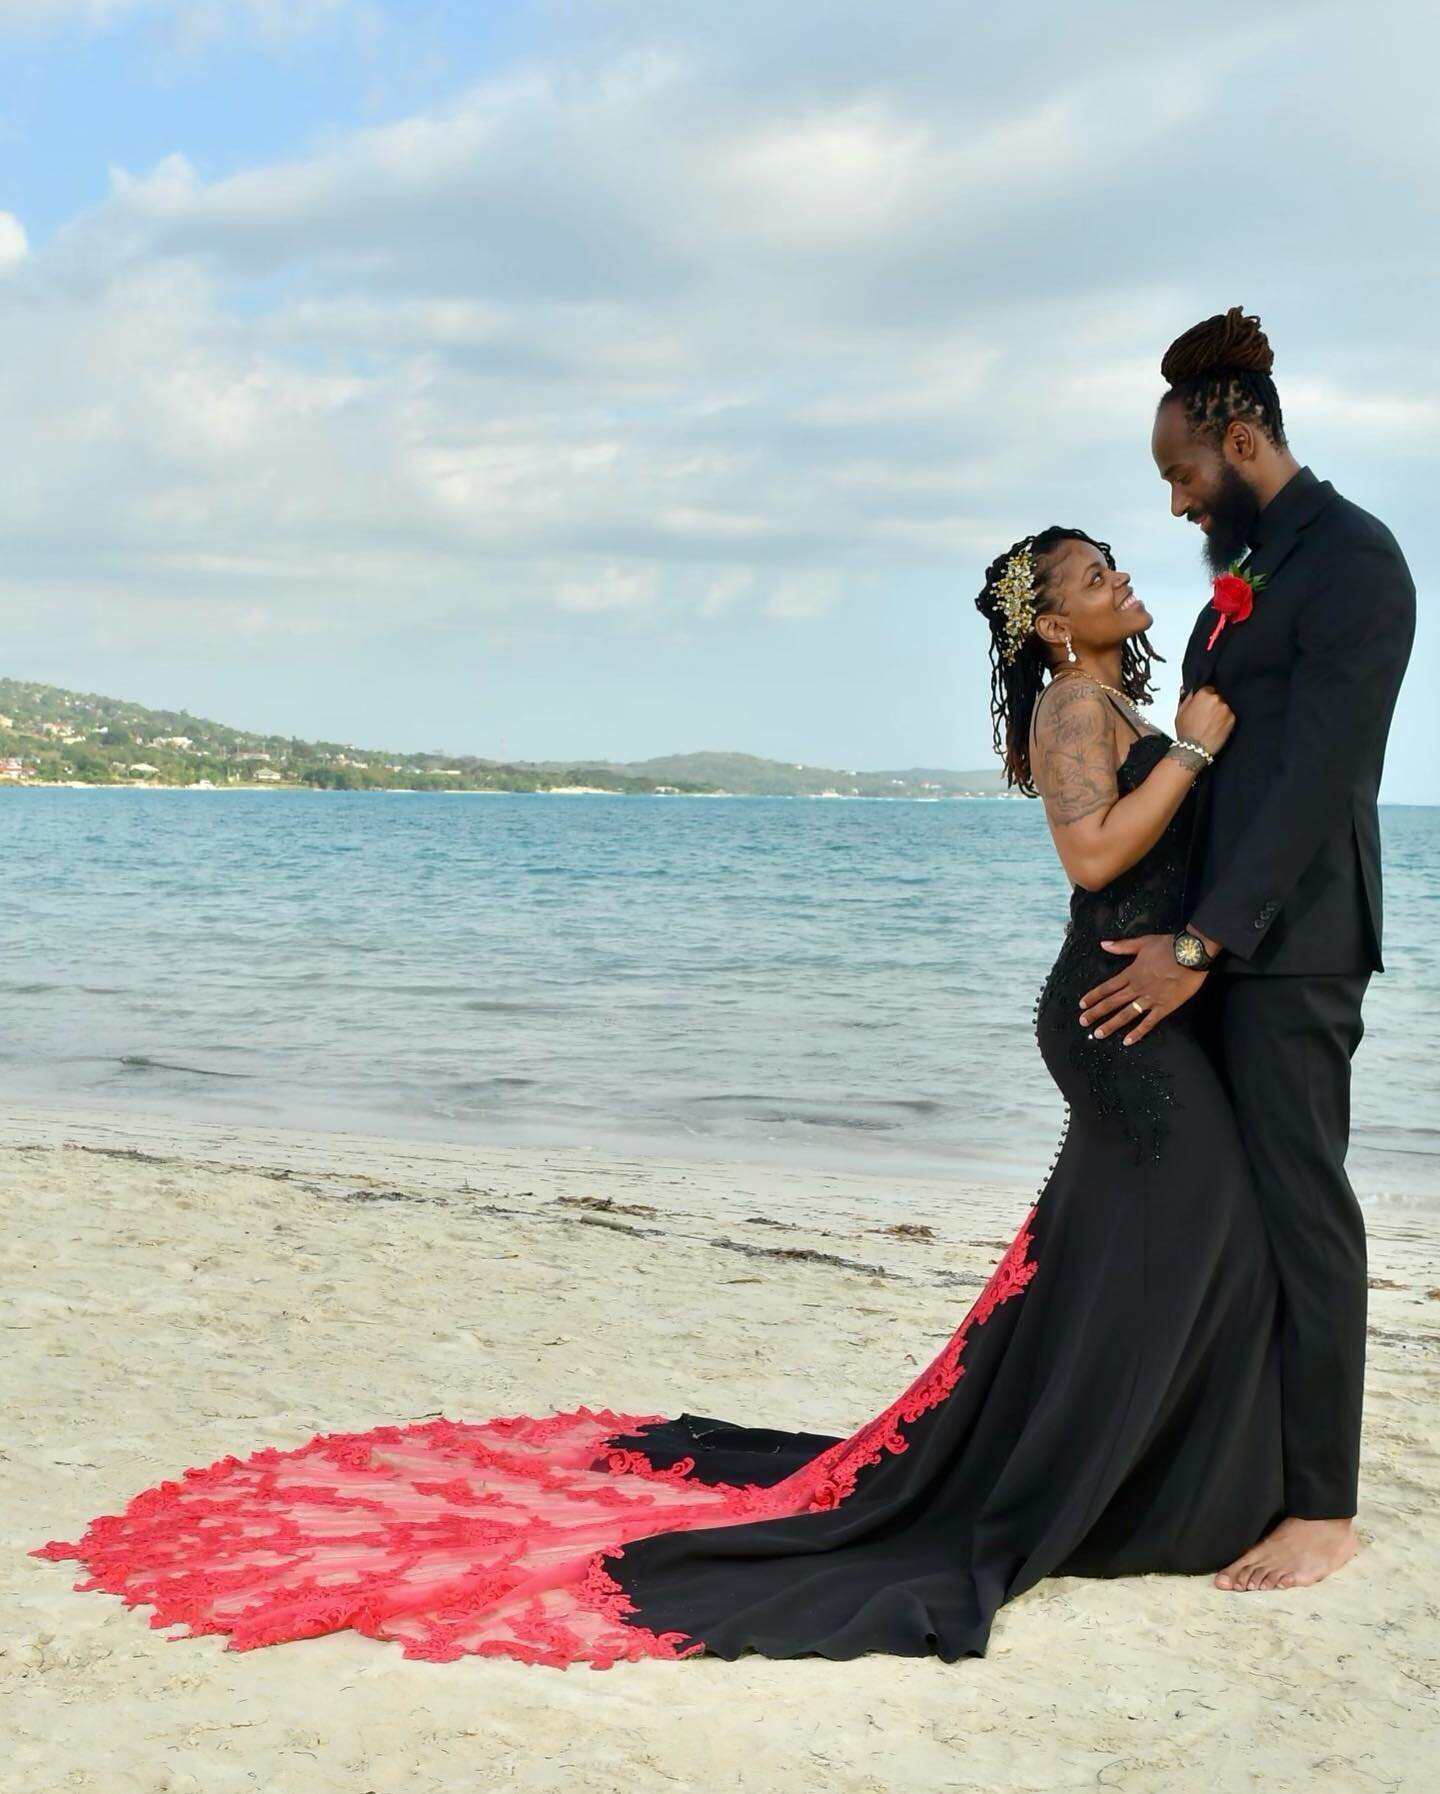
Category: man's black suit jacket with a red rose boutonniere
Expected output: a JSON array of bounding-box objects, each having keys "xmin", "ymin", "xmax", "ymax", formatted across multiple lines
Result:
[{"xmin": 1184, "ymin": 468, "xmax": 1415, "ymax": 974}]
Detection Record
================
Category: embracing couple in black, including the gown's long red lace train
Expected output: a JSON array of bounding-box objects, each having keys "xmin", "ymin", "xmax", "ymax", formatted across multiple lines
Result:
[{"xmin": 39, "ymin": 309, "xmax": 1415, "ymax": 1667}]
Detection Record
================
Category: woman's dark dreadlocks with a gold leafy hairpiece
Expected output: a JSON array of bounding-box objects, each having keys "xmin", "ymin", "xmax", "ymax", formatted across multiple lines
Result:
[{"xmin": 976, "ymin": 524, "xmax": 1162, "ymax": 797}]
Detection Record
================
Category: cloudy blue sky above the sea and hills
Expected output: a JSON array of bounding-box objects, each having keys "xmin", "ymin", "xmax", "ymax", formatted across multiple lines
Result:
[{"xmin": 0, "ymin": 0, "xmax": 1440, "ymax": 802}]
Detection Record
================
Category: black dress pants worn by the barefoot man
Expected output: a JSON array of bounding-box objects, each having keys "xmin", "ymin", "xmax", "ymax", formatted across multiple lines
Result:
[{"xmin": 1210, "ymin": 972, "xmax": 1370, "ymax": 1520}]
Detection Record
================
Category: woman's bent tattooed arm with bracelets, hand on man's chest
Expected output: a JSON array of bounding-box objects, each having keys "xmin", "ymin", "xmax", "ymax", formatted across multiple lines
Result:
[{"xmin": 1033, "ymin": 678, "xmax": 1196, "ymax": 892}]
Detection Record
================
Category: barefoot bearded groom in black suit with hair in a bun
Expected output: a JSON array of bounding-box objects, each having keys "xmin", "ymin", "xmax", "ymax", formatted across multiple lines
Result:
[{"xmin": 1080, "ymin": 307, "xmax": 1415, "ymax": 1589}]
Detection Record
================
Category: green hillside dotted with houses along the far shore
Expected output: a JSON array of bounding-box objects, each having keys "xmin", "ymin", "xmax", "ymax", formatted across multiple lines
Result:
[{"xmin": 0, "ymin": 678, "xmax": 1002, "ymax": 797}]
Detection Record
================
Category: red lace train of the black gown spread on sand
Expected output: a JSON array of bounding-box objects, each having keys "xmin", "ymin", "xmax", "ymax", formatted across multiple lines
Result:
[{"xmin": 34, "ymin": 1211, "xmax": 1037, "ymax": 1668}]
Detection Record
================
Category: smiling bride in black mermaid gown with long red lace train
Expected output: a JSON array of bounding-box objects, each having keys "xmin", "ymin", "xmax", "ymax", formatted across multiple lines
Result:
[{"xmin": 38, "ymin": 529, "xmax": 1282, "ymax": 1668}]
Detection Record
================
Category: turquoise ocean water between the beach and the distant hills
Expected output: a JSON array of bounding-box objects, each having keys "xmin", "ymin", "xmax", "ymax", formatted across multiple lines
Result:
[{"xmin": 0, "ymin": 789, "xmax": 1440, "ymax": 1202}]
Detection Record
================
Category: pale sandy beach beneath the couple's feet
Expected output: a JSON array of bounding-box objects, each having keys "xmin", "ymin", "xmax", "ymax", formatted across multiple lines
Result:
[{"xmin": 0, "ymin": 1109, "xmax": 1440, "ymax": 1794}]
